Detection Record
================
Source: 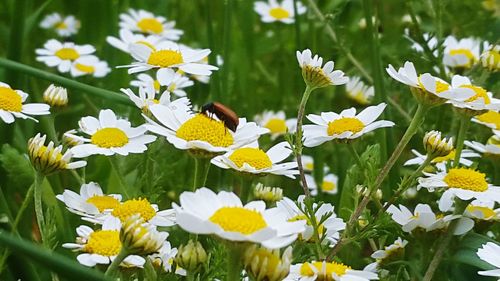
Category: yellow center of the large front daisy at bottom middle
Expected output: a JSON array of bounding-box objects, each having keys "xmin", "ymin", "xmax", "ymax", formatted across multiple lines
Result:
[{"xmin": 209, "ymin": 207, "xmax": 267, "ymax": 235}]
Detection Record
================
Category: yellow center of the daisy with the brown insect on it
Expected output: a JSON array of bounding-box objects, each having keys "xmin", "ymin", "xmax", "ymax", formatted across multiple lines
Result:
[{"xmin": 176, "ymin": 114, "xmax": 234, "ymax": 147}]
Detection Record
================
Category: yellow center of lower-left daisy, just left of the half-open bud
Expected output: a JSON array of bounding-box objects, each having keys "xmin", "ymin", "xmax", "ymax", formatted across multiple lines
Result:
[{"xmin": 83, "ymin": 230, "xmax": 122, "ymax": 257}]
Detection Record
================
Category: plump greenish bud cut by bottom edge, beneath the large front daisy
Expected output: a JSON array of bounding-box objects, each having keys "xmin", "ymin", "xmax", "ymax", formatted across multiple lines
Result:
[{"xmin": 243, "ymin": 245, "xmax": 292, "ymax": 281}]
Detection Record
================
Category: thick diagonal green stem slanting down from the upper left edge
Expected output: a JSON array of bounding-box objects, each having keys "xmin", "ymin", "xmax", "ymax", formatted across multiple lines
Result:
[{"xmin": 0, "ymin": 58, "xmax": 133, "ymax": 105}]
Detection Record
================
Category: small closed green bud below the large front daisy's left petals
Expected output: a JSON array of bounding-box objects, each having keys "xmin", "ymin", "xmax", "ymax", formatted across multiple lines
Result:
[{"xmin": 175, "ymin": 240, "xmax": 207, "ymax": 272}]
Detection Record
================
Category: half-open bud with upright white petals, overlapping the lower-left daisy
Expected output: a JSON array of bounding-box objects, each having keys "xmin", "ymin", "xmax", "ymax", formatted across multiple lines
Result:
[{"xmin": 120, "ymin": 214, "xmax": 168, "ymax": 255}]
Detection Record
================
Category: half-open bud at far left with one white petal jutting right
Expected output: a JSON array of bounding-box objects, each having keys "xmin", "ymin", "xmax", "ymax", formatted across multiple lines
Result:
[{"xmin": 28, "ymin": 134, "xmax": 87, "ymax": 175}]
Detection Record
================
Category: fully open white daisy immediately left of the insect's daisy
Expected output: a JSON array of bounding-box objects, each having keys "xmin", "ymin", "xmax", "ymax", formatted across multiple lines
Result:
[{"xmin": 67, "ymin": 109, "xmax": 156, "ymax": 158}]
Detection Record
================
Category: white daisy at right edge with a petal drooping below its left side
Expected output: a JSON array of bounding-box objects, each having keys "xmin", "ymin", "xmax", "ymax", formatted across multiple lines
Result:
[{"xmin": 418, "ymin": 168, "xmax": 500, "ymax": 211}]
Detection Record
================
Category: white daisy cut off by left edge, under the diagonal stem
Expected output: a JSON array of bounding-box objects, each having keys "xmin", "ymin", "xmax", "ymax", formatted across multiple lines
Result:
[{"xmin": 0, "ymin": 82, "xmax": 50, "ymax": 124}]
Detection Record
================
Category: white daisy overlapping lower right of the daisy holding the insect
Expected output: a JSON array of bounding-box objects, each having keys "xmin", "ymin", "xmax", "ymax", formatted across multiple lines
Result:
[{"xmin": 211, "ymin": 142, "xmax": 299, "ymax": 179}]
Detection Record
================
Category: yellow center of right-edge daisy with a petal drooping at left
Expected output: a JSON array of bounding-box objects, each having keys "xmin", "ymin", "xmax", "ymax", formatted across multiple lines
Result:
[{"xmin": 444, "ymin": 168, "xmax": 488, "ymax": 192}]
